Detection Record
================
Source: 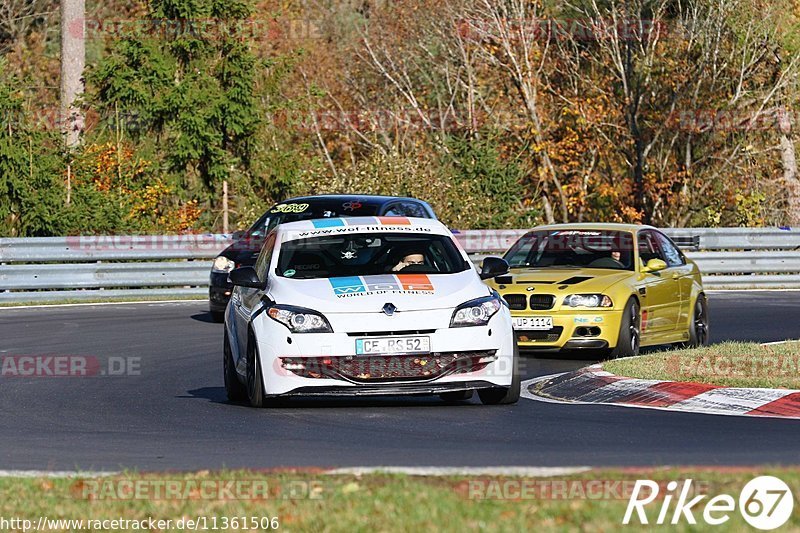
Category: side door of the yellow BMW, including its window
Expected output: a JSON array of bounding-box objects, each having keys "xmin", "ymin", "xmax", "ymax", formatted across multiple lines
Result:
[{"xmin": 637, "ymin": 229, "xmax": 681, "ymax": 340}]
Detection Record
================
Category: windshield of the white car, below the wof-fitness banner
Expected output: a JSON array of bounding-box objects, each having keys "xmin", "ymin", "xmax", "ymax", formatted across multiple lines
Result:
[{"xmin": 277, "ymin": 233, "xmax": 470, "ymax": 279}]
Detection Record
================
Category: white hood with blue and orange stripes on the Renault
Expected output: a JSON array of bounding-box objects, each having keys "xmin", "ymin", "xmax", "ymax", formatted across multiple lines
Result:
[{"xmin": 268, "ymin": 269, "xmax": 491, "ymax": 314}]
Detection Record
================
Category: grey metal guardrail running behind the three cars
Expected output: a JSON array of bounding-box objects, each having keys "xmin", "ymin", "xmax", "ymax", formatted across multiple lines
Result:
[{"xmin": 0, "ymin": 228, "xmax": 800, "ymax": 302}]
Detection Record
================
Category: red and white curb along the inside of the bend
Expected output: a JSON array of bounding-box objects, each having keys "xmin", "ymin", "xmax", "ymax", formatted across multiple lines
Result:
[{"xmin": 522, "ymin": 365, "xmax": 800, "ymax": 419}]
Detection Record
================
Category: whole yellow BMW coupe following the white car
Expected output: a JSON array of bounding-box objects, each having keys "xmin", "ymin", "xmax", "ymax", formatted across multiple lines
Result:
[{"xmin": 488, "ymin": 224, "xmax": 709, "ymax": 357}]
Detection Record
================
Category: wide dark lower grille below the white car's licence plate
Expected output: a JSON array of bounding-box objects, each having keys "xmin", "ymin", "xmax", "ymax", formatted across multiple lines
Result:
[{"xmin": 281, "ymin": 350, "xmax": 497, "ymax": 383}]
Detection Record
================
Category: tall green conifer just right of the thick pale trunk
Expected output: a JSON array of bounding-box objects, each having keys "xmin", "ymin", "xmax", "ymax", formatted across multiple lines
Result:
[{"xmin": 91, "ymin": 0, "xmax": 261, "ymax": 212}]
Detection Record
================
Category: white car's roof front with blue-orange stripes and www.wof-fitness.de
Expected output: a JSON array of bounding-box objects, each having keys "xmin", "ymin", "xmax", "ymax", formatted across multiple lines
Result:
[{"xmin": 275, "ymin": 216, "xmax": 453, "ymax": 241}]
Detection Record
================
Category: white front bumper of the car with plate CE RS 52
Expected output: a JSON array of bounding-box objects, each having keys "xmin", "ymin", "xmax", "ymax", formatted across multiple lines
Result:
[{"xmin": 254, "ymin": 308, "xmax": 516, "ymax": 396}]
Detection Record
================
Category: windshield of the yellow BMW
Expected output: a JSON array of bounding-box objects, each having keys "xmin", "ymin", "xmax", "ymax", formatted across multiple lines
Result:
[{"xmin": 505, "ymin": 229, "xmax": 633, "ymax": 270}]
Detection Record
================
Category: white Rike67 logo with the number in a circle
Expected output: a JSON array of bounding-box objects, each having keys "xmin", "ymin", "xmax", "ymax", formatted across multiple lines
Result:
[{"xmin": 622, "ymin": 476, "xmax": 794, "ymax": 531}]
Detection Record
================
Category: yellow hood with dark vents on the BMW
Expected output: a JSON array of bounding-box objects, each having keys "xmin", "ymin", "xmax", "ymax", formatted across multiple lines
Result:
[{"xmin": 492, "ymin": 268, "xmax": 634, "ymax": 292}]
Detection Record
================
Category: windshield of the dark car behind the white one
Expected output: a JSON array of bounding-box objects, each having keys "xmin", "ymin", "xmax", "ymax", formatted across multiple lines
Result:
[{"xmin": 247, "ymin": 200, "xmax": 378, "ymax": 237}]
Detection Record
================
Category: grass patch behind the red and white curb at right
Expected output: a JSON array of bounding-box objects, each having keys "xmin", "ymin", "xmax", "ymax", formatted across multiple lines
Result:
[{"xmin": 603, "ymin": 341, "xmax": 800, "ymax": 389}]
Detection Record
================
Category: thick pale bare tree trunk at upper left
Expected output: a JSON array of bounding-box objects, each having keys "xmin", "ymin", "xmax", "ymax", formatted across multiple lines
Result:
[{"xmin": 60, "ymin": 0, "xmax": 86, "ymax": 149}]
